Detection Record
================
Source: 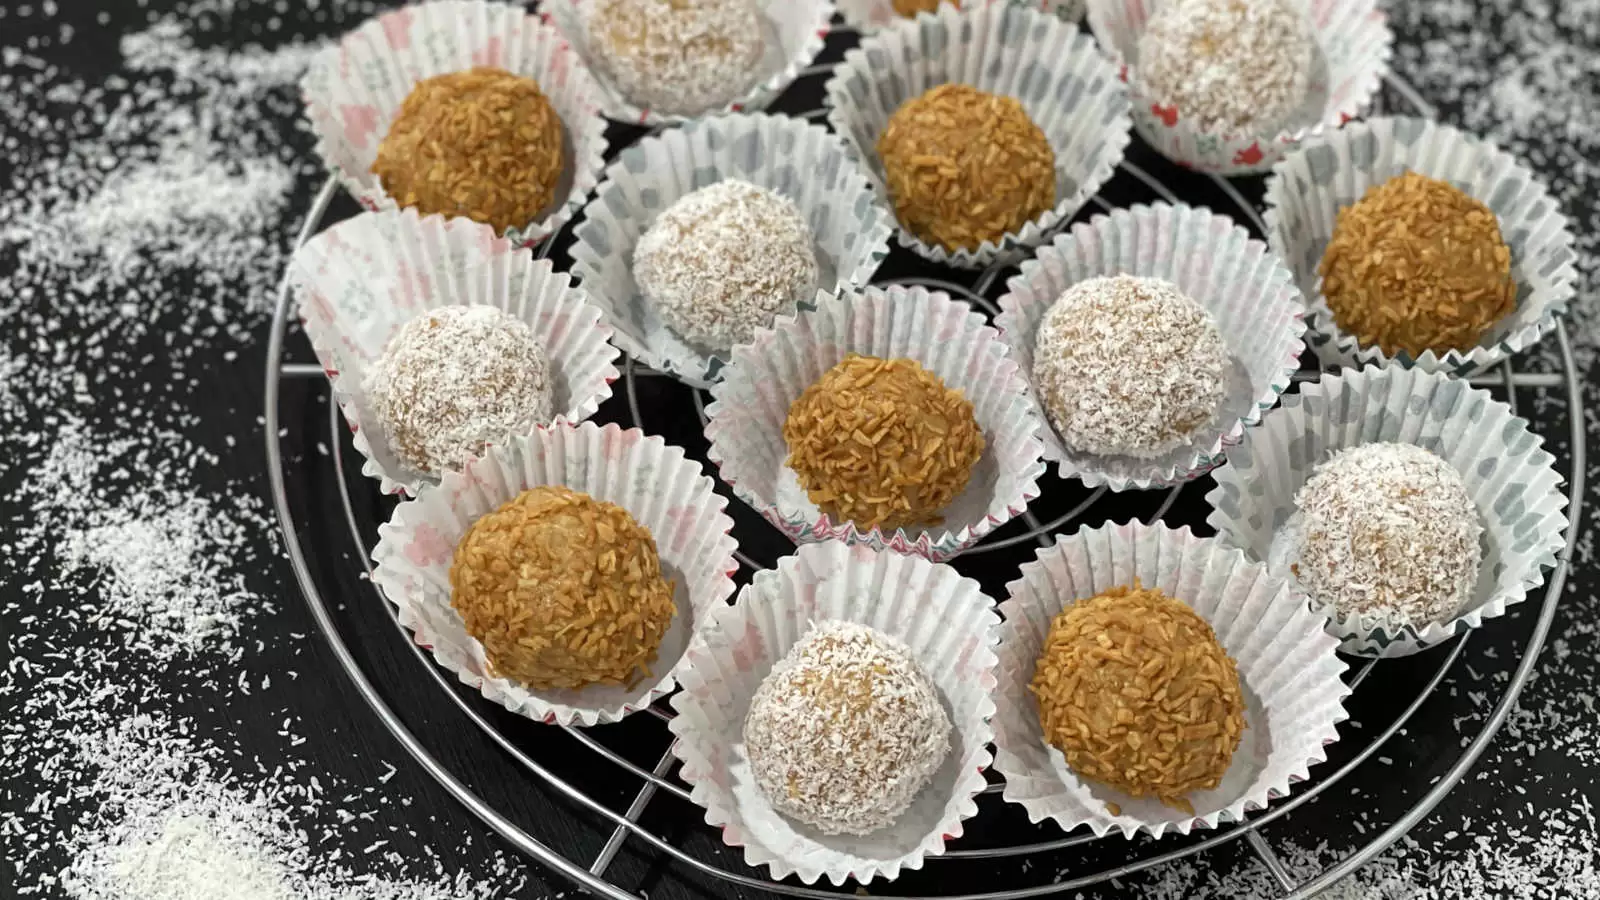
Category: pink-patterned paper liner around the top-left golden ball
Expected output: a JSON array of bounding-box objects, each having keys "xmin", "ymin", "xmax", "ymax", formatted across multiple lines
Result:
[{"xmin": 301, "ymin": 0, "xmax": 606, "ymax": 245}]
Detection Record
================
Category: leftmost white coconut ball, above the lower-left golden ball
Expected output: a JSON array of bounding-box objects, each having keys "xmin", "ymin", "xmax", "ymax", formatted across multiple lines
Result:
[{"xmin": 362, "ymin": 306, "xmax": 554, "ymax": 476}]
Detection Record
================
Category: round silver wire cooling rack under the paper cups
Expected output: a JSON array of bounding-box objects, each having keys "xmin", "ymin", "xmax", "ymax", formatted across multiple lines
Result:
[{"xmin": 264, "ymin": 38, "xmax": 1586, "ymax": 900}]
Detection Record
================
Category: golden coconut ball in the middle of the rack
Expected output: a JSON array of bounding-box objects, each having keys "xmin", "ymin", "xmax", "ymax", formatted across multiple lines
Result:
[{"xmin": 784, "ymin": 354, "xmax": 984, "ymax": 530}]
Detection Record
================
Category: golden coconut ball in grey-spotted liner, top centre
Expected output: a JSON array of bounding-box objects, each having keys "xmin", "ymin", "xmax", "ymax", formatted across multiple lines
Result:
[{"xmin": 878, "ymin": 85, "xmax": 1056, "ymax": 250}]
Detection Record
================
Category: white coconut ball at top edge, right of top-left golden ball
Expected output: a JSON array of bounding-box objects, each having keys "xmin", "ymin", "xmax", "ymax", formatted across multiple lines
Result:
[{"xmin": 586, "ymin": 0, "xmax": 766, "ymax": 115}]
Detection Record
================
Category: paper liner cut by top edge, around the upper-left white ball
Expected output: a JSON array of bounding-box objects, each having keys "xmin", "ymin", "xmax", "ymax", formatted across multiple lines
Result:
[{"xmin": 539, "ymin": 0, "xmax": 834, "ymax": 127}]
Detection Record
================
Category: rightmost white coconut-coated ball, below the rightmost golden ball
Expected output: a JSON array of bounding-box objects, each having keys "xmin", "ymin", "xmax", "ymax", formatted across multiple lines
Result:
[{"xmin": 1291, "ymin": 444, "xmax": 1483, "ymax": 626}]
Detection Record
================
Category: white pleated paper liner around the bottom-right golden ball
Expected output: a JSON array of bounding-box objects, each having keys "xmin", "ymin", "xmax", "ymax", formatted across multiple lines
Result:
[{"xmin": 995, "ymin": 522, "xmax": 1350, "ymax": 838}]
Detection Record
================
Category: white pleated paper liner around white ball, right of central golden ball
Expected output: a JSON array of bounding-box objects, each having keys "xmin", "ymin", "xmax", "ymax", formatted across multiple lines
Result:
[{"xmin": 995, "ymin": 203, "xmax": 1306, "ymax": 490}]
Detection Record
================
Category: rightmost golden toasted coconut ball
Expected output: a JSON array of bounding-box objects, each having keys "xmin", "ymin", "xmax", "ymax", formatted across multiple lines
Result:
[{"xmin": 1317, "ymin": 171, "xmax": 1517, "ymax": 357}]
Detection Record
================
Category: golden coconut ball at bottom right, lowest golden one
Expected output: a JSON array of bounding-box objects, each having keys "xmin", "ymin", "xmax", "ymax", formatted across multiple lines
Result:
[{"xmin": 1030, "ymin": 585, "xmax": 1245, "ymax": 815}]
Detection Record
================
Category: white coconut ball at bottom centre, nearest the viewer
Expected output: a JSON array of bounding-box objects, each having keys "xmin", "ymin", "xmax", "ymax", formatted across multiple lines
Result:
[{"xmin": 744, "ymin": 621, "xmax": 950, "ymax": 834}]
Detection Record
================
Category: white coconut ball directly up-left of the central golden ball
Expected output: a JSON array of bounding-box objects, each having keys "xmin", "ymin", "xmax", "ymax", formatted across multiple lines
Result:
[{"xmin": 634, "ymin": 181, "xmax": 818, "ymax": 352}]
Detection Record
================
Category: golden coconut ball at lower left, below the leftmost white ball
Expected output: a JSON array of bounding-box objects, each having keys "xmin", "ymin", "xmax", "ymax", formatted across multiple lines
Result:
[{"xmin": 450, "ymin": 487, "xmax": 677, "ymax": 690}]
